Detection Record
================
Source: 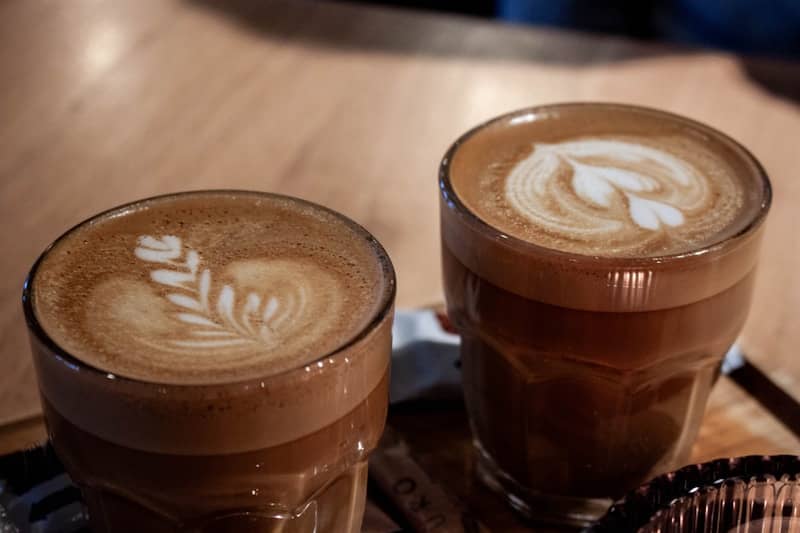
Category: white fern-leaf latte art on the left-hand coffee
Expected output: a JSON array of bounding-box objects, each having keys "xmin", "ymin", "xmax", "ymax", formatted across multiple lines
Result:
[{"xmin": 135, "ymin": 235, "xmax": 334, "ymax": 351}]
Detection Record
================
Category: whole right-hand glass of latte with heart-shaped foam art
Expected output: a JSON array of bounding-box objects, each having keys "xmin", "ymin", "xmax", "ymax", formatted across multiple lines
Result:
[{"xmin": 439, "ymin": 103, "xmax": 771, "ymax": 525}]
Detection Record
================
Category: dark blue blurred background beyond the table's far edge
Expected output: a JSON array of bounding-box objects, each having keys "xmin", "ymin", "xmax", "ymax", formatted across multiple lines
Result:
[{"xmin": 342, "ymin": 0, "xmax": 800, "ymax": 58}]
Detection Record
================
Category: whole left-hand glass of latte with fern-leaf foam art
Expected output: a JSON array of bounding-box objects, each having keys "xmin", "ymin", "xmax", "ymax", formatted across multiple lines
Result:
[{"xmin": 24, "ymin": 191, "xmax": 395, "ymax": 533}]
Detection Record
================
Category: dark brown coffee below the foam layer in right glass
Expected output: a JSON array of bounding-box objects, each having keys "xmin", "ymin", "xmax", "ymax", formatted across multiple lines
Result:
[{"xmin": 443, "ymin": 249, "xmax": 753, "ymax": 497}]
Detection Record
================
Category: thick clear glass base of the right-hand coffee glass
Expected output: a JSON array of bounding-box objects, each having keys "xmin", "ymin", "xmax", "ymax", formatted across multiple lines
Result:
[{"xmin": 475, "ymin": 442, "xmax": 613, "ymax": 527}]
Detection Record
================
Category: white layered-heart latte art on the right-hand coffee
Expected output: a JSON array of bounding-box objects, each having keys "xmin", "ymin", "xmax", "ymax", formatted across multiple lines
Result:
[{"xmin": 505, "ymin": 139, "xmax": 713, "ymax": 248}]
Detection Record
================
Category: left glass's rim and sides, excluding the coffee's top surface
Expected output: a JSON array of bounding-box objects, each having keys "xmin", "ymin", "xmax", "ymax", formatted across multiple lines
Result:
[{"xmin": 23, "ymin": 191, "xmax": 395, "ymax": 533}]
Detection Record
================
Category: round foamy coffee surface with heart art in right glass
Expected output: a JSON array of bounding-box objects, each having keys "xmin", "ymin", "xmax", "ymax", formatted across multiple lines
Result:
[{"xmin": 450, "ymin": 106, "xmax": 763, "ymax": 257}]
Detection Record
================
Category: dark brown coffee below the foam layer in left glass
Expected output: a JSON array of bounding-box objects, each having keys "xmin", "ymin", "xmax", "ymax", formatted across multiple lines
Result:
[{"xmin": 43, "ymin": 374, "xmax": 388, "ymax": 533}]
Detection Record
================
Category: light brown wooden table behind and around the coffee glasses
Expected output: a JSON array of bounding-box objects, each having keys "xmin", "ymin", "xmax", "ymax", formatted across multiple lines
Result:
[{"xmin": 0, "ymin": 0, "xmax": 800, "ymax": 528}]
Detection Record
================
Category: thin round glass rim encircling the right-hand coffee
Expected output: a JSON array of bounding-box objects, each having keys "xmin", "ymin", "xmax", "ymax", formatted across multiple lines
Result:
[{"xmin": 438, "ymin": 101, "xmax": 772, "ymax": 267}]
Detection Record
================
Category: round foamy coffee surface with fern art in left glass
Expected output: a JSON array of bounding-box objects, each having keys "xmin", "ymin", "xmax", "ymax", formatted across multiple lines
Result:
[{"xmin": 32, "ymin": 192, "xmax": 386, "ymax": 384}]
